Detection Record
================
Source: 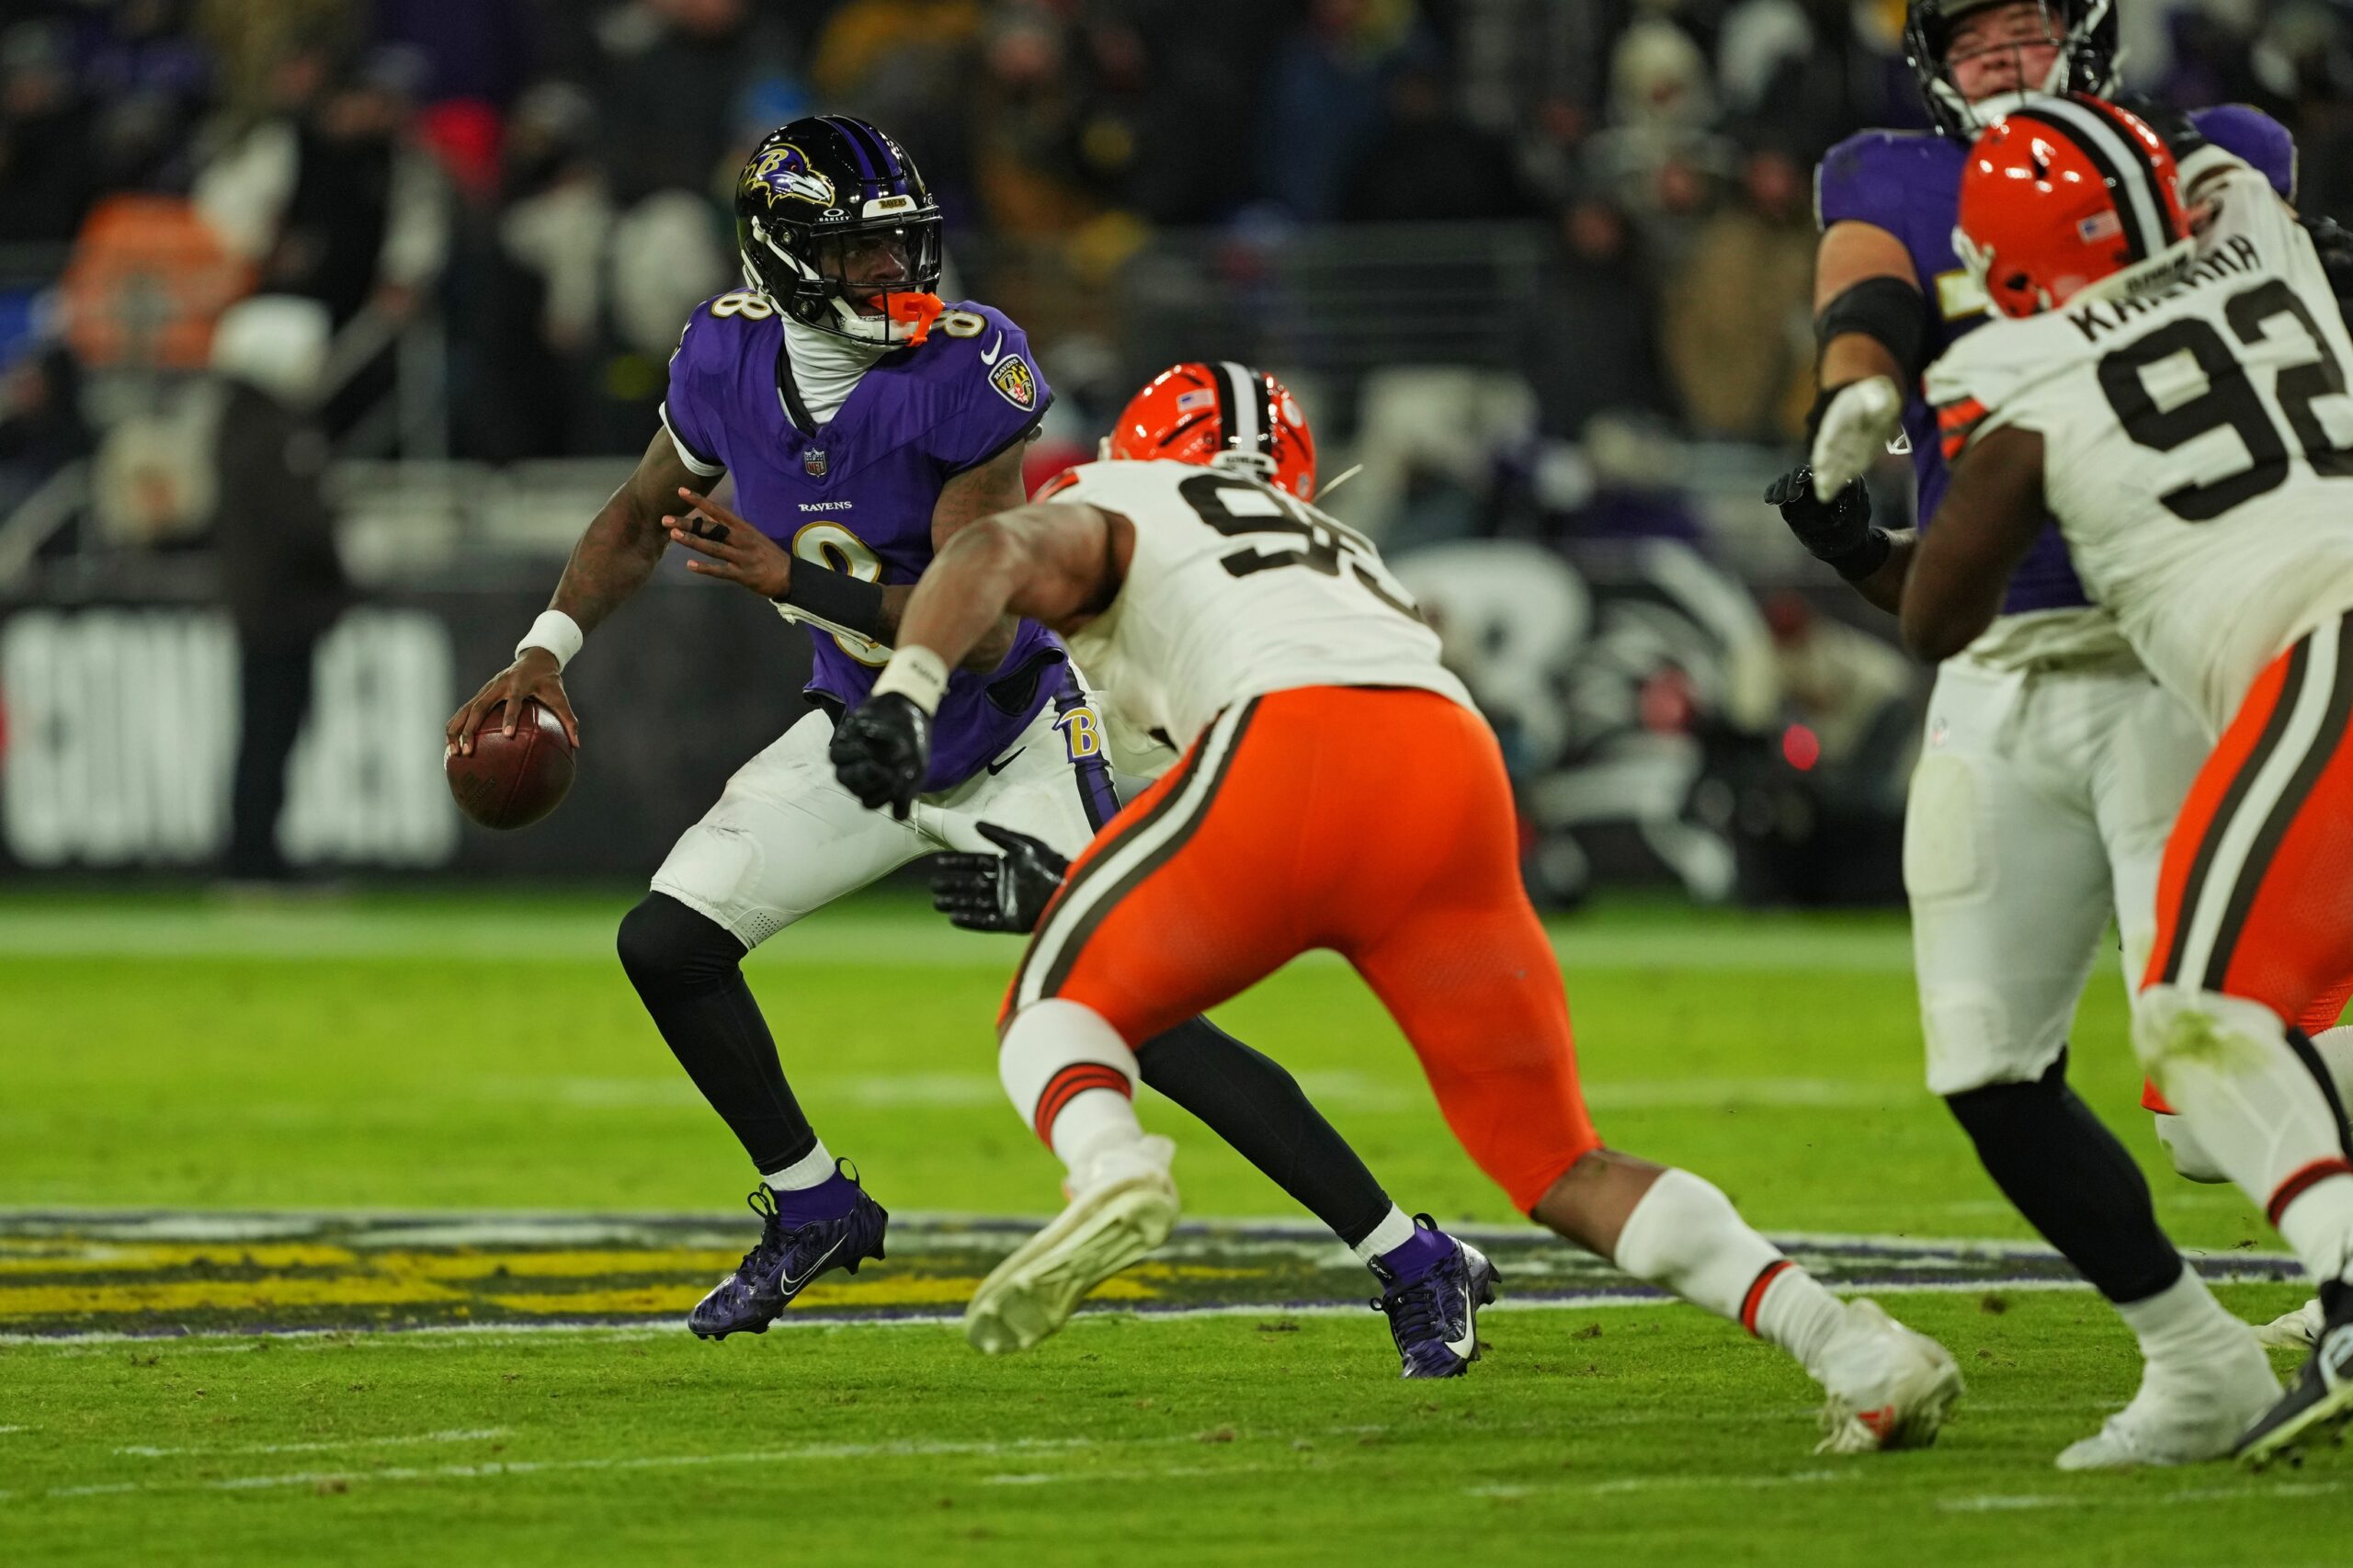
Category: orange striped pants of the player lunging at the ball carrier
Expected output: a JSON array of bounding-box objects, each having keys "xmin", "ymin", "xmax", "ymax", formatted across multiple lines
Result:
[{"xmin": 1000, "ymin": 685, "xmax": 1600, "ymax": 1212}]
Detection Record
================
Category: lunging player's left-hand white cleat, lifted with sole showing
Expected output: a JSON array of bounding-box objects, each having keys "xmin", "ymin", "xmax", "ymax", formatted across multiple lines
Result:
[{"xmin": 965, "ymin": 1137, "xmax": 1176, "ymax": 1356}]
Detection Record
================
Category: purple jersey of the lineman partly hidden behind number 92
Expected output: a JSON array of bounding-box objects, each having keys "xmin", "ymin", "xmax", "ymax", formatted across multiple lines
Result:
[{"xmin": 1814, "ymin": 104, "xmax": 2297, "ymax": 615}]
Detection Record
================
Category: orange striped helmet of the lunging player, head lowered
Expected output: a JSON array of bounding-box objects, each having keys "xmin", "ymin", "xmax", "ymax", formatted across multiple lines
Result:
[{"xmin": 1104, "ymin": 360, "xmax": 1315, "ymax": 502}]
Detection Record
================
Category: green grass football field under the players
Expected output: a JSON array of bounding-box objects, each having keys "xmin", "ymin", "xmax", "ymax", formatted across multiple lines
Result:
[{"xmin": 0, "ymin": 890, "xmax": 2353, "ymax": 1565}]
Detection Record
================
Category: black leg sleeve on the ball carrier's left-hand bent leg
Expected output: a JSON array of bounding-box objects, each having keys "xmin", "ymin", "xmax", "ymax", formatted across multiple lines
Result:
[{"xmin": 619, "ymin": 892, "xmax": 816, "ymax": 1170}]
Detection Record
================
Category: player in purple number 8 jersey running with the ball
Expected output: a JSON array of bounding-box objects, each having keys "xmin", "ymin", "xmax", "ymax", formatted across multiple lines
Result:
[{"xmin": 449, "ymin": 116, "xmax": 1463, "ymax": 1378}]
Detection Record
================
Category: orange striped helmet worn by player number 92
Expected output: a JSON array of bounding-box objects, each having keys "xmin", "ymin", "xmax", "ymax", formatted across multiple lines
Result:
[{"xmin": 1953, "ymin": 94, "xmax": 2193, "ymax": 315}]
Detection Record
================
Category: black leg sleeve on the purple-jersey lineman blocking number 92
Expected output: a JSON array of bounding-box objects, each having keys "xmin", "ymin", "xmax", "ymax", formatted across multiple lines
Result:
[{"xmin": 1946, "ymin": 1055, "xmax": 2181, "ymax": 1304}]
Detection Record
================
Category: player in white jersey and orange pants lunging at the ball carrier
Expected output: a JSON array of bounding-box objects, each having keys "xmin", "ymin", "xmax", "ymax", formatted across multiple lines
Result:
[{"xmin": 780, "ymin": 371, "xmax": 1960, "ymax": 1452}]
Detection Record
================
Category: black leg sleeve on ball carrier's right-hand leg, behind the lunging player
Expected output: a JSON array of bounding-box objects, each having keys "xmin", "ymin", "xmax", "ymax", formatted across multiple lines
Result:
[{"xmin": 1136, "ymin": 1017, "xmax": 1388, "ymax": 1245}]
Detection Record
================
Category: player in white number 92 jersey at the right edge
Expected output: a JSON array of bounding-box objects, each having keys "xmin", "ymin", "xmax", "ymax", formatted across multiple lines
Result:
[{"xmin": 1901, "ymin": 97, "xmax": 2353, "ymax": 1462}]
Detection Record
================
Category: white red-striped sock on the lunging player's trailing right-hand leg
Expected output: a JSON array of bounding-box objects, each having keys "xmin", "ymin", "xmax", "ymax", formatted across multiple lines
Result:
[{"xmin": 1612, "ymin": 1170, "xmax": 1847, "ymax": 1372}]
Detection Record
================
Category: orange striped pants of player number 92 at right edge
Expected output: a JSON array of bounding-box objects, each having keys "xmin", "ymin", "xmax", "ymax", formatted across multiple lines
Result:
[{"xmin": 2142, "ymin": 624, "xmax": 2353, "ymax": 1111}]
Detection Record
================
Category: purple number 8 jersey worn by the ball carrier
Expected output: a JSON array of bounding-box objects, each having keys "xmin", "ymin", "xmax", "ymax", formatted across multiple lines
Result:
[{"xmin": 661, "ymin": 292, "xmax": 1068, "ymax": 793}]
